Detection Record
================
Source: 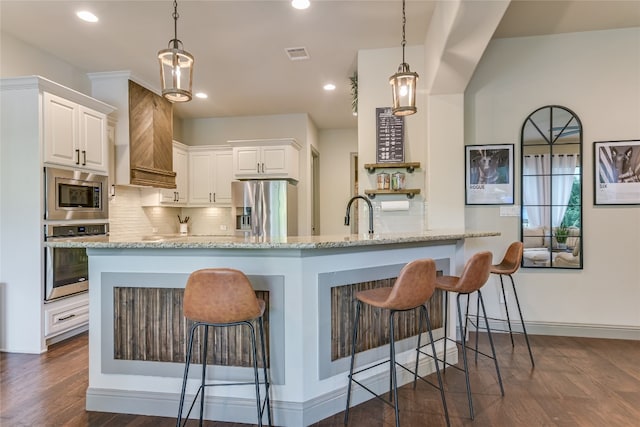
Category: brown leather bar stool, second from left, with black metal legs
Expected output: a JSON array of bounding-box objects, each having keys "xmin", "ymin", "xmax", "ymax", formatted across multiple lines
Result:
[{"xmin": 344, "ymin": 259, "xmax": 449, "ymax": 427}]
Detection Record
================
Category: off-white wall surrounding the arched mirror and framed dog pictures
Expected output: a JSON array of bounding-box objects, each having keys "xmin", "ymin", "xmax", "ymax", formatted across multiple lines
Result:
[{"xmin": 464, "ymin": 28, "xmax": 640, "ymax": 339}]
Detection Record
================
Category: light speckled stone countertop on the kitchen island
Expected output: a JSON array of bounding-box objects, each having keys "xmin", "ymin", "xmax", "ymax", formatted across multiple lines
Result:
[{"xmin": 44, "ymin": 230, "xmax": 500, "ymax": 249}]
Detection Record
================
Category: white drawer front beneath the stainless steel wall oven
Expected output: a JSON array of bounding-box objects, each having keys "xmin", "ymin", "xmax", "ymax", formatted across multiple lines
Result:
[{"xmin": 44, "ymin": 292, "xmax": 89, "ymax": 338}]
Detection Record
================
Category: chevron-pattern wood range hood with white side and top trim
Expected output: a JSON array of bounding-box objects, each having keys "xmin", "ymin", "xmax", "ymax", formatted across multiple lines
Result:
[{"xmin": 88, "ymin": 71, "xmax": 176, "ymax": 188}]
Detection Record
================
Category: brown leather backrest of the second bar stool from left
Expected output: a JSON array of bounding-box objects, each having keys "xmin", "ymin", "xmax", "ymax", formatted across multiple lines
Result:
[{"xmin": 383, "ymin": 258, "xmax": 436, "ymax": 310}]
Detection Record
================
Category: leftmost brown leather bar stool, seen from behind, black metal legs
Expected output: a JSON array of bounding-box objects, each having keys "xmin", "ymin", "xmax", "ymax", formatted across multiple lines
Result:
[{"xmin": 176, "ymin": 268, "xmax": 271, "ymax": 427}]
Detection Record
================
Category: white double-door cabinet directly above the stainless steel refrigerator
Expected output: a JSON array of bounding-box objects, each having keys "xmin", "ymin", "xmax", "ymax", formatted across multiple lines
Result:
[{"xmin": 229, "ymin": 138, "xmax": 300, "ymax": 181}]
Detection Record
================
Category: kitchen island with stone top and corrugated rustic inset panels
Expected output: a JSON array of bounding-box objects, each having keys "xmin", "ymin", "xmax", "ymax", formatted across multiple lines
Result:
[{"xmin": 50, "ymin": 230, "xmax": 498, "ymax": 426}]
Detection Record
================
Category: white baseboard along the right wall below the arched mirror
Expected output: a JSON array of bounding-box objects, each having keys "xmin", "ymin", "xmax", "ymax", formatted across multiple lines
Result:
[{"xmin": 464, "ymin": 317, "xmax": 640, "ymax": 341}]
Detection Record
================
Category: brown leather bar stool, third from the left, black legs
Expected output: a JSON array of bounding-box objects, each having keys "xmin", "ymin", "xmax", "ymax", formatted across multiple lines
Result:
[{"xmin": 436, "ymin": 251, "xmax": 504, "ymax": 419}]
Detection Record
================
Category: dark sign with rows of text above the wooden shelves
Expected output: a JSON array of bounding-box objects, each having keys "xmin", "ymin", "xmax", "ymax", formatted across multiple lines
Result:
[{"xmin": 376, "ymin": 107, "xmax": 404, "ymax": 163}]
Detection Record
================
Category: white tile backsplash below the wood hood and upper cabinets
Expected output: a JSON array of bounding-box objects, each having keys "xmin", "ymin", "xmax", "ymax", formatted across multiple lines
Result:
[{"xmin": 109, "ymin": 186, "xmax": 234, "ymax": 237}]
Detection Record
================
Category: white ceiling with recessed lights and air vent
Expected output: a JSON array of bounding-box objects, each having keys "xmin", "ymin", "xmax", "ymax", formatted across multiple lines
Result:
[{"xmin": 0, "ymin": 0, "xmax": 640, "ymax": 128}]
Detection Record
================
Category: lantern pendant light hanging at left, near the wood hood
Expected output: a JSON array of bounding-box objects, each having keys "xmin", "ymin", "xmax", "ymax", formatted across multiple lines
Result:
[{"xmin": 158, "ymin": 1, "xmax": 193, "ymax": 102}]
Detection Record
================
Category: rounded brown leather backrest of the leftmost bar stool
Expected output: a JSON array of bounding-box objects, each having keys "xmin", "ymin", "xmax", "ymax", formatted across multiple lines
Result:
[{"xmin": 182, "ymin": 268, "xmax": 264, "ymax": 323}]
